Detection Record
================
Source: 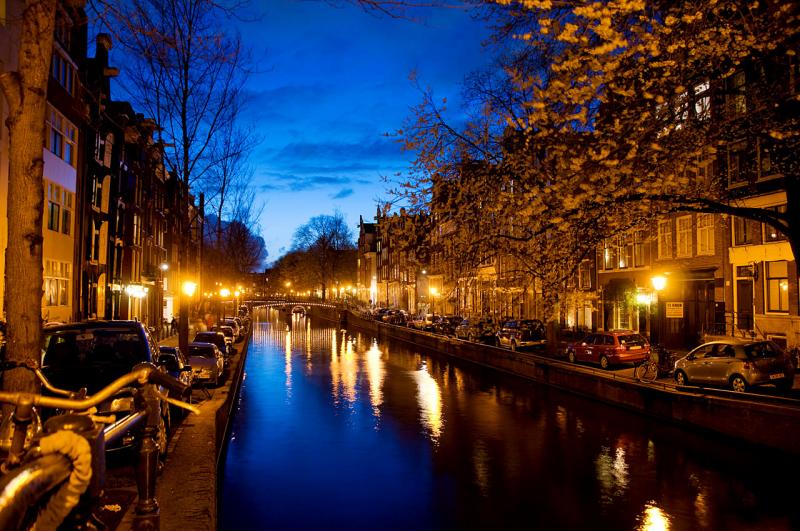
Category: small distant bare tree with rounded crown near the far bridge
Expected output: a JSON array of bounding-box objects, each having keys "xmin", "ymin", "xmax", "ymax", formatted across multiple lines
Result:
[{"xmin": 292, "ymin": 212, "xmax": 355, "ymax": 300}]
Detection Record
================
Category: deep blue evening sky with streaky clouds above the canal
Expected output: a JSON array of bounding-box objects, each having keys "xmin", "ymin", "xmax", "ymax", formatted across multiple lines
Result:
[{"xmin": 241, "ymin": 0, "xmax": 489, "ymax": 262}]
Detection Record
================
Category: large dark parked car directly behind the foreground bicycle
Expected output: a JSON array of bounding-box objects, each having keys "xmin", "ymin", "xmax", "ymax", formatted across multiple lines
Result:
[{"xmin": 41, "ymin": 321, "xmax": 170, "ymax": 456}]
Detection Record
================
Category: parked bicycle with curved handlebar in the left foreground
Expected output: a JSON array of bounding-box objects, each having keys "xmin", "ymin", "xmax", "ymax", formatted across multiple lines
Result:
[{"xmin": 0, "ymin": 360, "xmax": 199, "ymax": 530}]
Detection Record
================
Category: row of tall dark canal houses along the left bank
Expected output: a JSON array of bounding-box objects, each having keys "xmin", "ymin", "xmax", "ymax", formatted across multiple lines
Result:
[{"xmin": 0, "ymin": 1, "xmax": 202, "ymax": 326}]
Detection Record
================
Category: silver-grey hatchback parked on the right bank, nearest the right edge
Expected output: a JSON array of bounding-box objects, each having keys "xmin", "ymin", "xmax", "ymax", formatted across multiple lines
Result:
[{"xmin": 675, "ymin": 339, "xmax": 795, "ymax": 392}]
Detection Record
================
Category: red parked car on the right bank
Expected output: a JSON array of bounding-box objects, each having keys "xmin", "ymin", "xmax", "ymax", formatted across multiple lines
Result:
[{"xmin": 567, "ymin": 330, "xmax": 650, "ymax": 369}]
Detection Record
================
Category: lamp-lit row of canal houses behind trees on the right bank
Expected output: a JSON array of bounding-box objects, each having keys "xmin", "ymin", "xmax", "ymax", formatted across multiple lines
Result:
[{"xmin": 358, "ymin": 94, "xmax": 800, "ymax": 349}]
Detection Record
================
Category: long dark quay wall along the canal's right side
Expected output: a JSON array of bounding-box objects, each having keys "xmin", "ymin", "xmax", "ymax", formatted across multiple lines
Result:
[{"xmin": 311, "ymin": 307, "xmax": 800, "ymax": 454}]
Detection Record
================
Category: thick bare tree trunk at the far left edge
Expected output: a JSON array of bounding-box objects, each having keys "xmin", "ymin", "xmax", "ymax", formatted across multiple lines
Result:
[{"xmin": 0, "ymin": 0, "xmax": 56, "ymax": 400}]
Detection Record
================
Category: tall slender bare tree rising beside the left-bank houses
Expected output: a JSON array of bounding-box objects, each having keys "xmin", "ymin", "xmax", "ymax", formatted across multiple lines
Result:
[{"xmin": 98, "ymin": 0, "xmax": 252, "ymax": 358}]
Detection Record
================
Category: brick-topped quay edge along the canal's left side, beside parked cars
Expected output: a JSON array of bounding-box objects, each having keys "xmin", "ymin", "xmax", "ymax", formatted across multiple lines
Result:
[{"xmin": 120, "ymin": 331, "xmax": 252, "ymax": 531}]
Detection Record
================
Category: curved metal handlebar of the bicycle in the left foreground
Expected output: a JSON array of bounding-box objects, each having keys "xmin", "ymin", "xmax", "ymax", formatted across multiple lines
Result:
[{"xmin": 0, "ymin": 362, "xmax": 188, "ymax": 410}]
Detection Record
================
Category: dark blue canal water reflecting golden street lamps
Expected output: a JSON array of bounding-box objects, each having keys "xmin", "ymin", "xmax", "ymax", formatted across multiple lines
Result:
[{"xmin": 219, "ymin": 310, "xmax": 800, "ymax": 531}]
